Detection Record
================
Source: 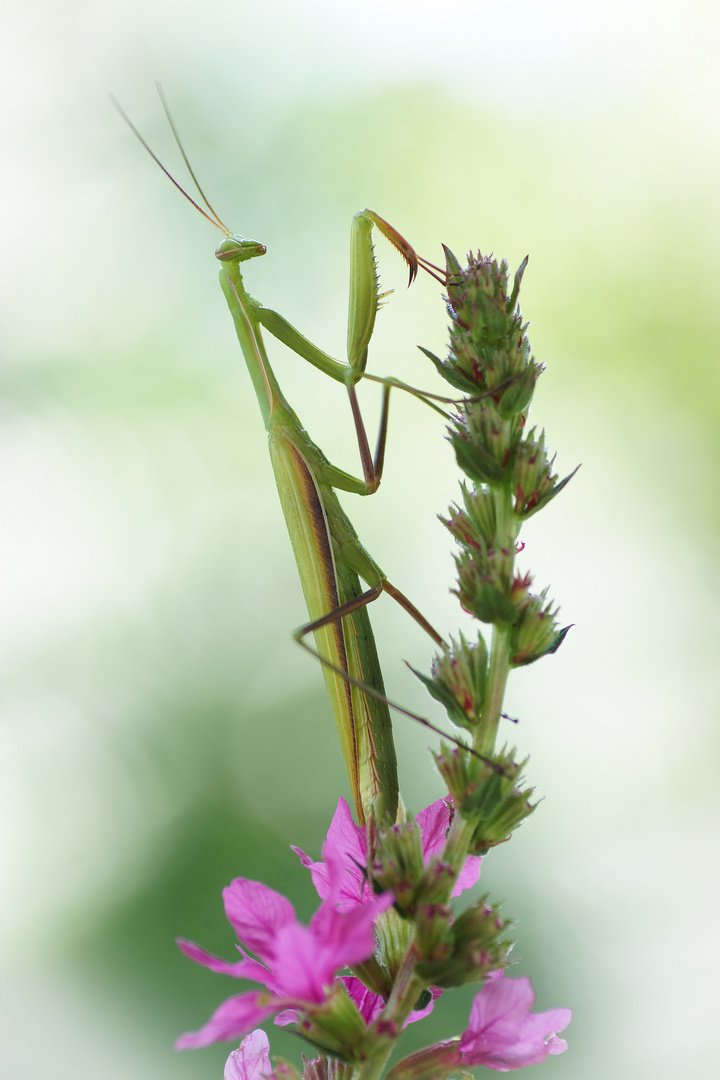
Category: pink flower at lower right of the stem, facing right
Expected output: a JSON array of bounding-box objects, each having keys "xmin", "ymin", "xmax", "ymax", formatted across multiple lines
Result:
[{"xmin": 459, "ymin": 973, "xmax": 572, "ymax": 1072}]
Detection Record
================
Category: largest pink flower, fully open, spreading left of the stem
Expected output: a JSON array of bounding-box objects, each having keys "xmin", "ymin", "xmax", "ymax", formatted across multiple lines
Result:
[{"xmin": 175, "ymin": 845, "xmax": 393, "ymax": 1050}]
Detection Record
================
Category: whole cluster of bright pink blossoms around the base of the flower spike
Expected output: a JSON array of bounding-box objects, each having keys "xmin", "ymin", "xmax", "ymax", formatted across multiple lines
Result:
[{"xmin": 181, "ymin": 799, "xmax": 571, "ymax": 1080}]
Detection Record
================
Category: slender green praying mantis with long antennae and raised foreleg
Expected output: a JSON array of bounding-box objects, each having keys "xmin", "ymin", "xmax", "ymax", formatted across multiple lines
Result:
[{"xmin": 111, "ymin": 95, "xmax": 451, "ymax": 824}]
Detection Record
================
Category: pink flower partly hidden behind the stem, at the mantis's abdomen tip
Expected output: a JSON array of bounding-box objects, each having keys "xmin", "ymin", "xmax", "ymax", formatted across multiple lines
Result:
[{"xmin": 293, "ymin": 796, "xmax": 483, "ymax": 912}]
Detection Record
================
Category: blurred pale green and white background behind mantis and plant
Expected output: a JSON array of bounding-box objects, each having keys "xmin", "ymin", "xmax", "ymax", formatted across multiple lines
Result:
[{"xmin": 0, "ymin": 0, "xmax": 720, "ymax": 1080}]
